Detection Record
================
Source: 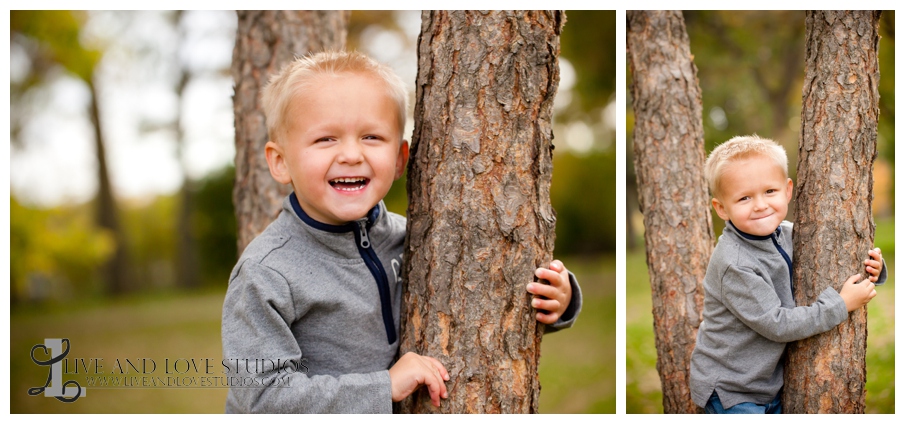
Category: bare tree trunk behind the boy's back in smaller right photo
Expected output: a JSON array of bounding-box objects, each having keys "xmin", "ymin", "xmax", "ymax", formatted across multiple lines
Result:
[{"xmin": 627, "ymin": 11, "xmax": 714, "ymax": 413}]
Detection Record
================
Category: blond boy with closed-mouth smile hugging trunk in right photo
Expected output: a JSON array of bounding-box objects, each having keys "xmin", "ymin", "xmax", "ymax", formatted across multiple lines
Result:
[{"xmin": 690, "ymin": 136, "xmax": 886, "ymax": 413}]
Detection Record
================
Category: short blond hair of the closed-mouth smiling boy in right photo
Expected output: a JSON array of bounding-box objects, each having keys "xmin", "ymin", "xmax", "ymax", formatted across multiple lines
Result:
[{"xmin": 704, "ymin": 134, "xmax": 789, "ymax": 197}]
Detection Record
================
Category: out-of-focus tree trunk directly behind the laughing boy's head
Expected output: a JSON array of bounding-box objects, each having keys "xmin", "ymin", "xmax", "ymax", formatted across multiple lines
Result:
[{"xmin": 232, "ymin": 10, "xmax": 349, "ymax": 254}]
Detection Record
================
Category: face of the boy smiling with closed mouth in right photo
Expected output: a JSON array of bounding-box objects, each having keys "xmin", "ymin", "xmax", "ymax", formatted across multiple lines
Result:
[{"xmin": 712, "ymin": 156, "xmax": 792, "ymax": 236}]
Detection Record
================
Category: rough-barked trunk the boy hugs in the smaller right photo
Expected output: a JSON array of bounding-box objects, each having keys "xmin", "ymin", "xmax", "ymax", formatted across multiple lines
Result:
[{"xmin": 783, "ymin": 11, "xmax": 880, "ymax": 413}]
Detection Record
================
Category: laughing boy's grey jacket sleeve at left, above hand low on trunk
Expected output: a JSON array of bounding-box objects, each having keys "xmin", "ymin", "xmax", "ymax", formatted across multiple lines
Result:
[{"xmin": 221, "ymin": 260, "xmax": 392, "ymax": 413}]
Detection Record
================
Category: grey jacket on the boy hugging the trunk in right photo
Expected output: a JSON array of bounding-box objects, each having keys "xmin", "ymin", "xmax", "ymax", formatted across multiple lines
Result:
[{"xmin": 690, "ymin": 221, "xmax": 886, "ymax": 408}]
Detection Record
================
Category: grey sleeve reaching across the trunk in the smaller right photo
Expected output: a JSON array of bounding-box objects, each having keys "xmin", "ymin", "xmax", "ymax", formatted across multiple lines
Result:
[{"xmin": 721, "ymin": 266, "xmax": 848, "ymax": 343}]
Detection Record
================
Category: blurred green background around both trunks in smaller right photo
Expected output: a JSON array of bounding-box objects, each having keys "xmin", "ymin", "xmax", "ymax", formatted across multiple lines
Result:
[{"xmin": 625, "ymin": 11, "xmax": 895, "ymax": 413}]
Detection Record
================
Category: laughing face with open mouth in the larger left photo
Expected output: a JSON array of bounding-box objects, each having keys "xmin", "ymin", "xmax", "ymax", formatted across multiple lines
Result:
[{"xmin": 265, "ymin": 73, "xmax": 408, "ymax": 225}]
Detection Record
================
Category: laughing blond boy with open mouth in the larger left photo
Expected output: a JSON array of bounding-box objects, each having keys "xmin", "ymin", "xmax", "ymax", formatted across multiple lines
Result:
[{"xmin": 222, "ymin": 52, "xmax": 581, "ymax": 413}]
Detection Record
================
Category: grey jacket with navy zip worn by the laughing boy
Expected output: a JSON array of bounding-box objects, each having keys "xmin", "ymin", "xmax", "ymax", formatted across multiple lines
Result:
[{"xmin": 221, "ymin": 194, "xmax": 581, "ymax": 413}]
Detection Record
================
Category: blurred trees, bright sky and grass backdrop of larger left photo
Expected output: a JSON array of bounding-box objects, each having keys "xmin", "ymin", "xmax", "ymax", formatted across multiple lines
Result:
[{"xmin": 9, "ymin": 10, "xmax": 616, "ymax": 413}]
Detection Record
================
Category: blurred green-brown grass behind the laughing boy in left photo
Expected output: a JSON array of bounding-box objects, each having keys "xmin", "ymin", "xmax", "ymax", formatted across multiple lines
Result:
[{"xmin": 10, "ymin": 258, "xmax": 616, "ymax": 413}]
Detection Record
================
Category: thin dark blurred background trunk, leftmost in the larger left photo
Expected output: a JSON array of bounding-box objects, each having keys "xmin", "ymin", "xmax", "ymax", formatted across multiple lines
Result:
[{"xmin": 86, "ymin": 80, "xmax": 134, "ymax": 294}]
